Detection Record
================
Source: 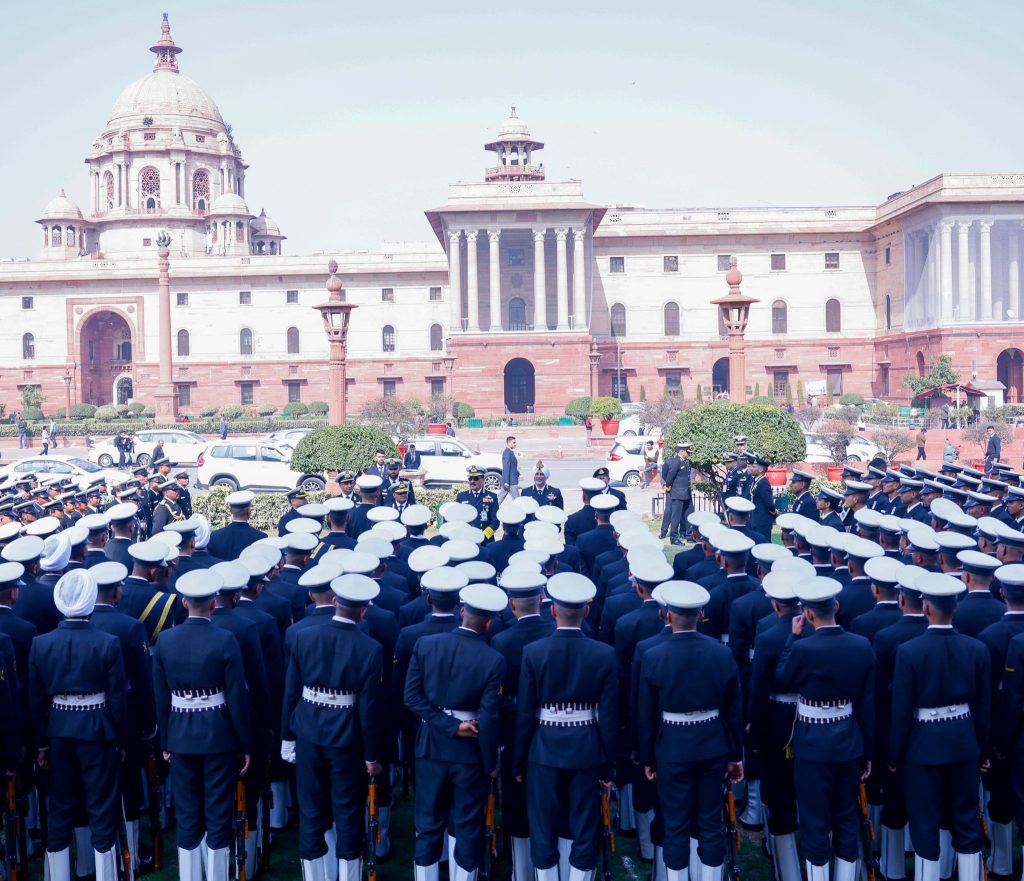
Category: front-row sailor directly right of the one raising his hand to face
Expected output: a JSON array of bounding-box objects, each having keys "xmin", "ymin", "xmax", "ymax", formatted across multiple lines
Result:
[{"xmin": 889, "ymin": 573, "xmax": 991, "ymax": 881}]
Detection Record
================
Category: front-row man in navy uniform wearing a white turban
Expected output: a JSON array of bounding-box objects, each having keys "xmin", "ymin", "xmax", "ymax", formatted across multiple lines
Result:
[{"xmin": 29, "ymin": 569, "xmax": 129, "ymax": 881}]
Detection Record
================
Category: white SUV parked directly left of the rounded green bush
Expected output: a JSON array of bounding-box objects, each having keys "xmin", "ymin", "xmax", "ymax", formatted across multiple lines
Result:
[{"xmin": 196, "ymin": 439, "xmax": 327, "ymax": 493}]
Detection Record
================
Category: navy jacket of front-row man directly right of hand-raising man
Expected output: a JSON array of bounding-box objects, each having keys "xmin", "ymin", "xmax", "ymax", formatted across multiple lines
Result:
[{"xmin": 889, "ymin": 627, "xmax": 991, "ymax": 767}]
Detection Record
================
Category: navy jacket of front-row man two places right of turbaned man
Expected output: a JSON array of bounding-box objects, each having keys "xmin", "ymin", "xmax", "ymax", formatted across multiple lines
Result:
[{"xmin": 281, "ymin": 617, "xmax": 384, "ymax": 762}]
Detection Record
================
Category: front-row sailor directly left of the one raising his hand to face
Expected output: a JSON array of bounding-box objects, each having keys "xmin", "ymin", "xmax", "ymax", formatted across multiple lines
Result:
[{"xmin": 637, "ymin": 581, "xmax": 743, "ymax": 881}]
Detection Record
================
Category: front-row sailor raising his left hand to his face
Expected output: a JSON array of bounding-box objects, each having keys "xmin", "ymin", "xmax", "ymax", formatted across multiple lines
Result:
[{"xmin": 774, "ymin": 578, "xmax": 874, "ymax": 881}]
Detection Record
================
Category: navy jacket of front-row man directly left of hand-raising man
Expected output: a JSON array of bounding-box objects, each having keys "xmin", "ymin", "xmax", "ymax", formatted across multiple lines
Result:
[{"xmin": 638, "ymin": 631, "xmax": 743, "ymax": 767}]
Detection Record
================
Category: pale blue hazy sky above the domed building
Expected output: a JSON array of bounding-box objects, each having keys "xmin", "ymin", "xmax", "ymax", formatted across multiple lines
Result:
[{"xmin": 0, "ymin": 0, "xmax": 1024, "ymax": 257}]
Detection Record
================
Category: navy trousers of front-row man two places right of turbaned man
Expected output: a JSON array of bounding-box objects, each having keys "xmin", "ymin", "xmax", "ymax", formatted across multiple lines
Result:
[{"xmin": 295, "ymin": 740, "xmax": 367, "ymax": 859}]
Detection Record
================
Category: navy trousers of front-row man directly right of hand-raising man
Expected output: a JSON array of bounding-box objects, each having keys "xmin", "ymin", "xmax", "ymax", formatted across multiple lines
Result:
[{"xmin": 903, "ymin": 760, "xmax": 982, "ymax": 859}]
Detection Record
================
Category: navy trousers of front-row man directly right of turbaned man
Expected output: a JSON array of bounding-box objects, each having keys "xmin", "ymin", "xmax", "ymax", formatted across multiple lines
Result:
[{"xmin": 169, "ymin": 752, "xmax": 239, "ymax": 850}]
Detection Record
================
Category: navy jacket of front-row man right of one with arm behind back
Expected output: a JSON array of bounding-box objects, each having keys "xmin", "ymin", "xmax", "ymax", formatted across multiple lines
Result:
[{"xmin": 513, "ymin": 628, "xmax": 618, "ymax": 780}]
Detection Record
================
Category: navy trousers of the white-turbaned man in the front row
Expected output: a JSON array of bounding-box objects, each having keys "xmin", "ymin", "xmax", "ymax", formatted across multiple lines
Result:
[{"xmin": 46, "ymin": 738, "xmax": 121, "ymax": 853}]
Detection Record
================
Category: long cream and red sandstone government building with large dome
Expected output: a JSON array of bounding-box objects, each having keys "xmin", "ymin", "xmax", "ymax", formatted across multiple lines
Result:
[{"xmin": 6, "ymin": 16, "xmax": 1024, "ymax": 415}]
